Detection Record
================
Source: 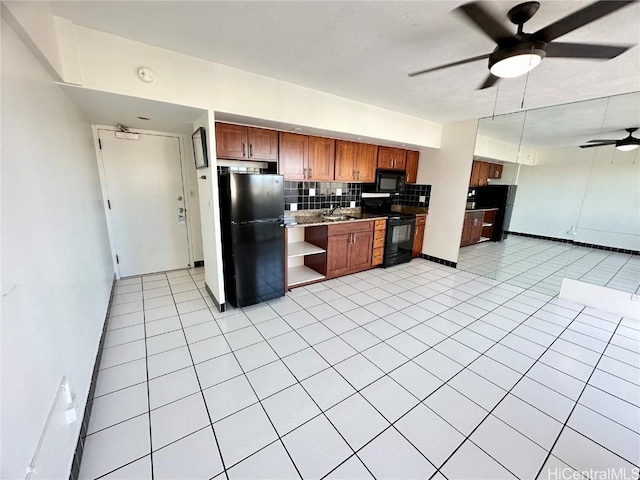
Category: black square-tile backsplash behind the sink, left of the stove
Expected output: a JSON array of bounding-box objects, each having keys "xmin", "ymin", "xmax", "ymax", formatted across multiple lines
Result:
[{"xmin": 284, "ymin": 181, "xmax": 362, "ymax": 210}]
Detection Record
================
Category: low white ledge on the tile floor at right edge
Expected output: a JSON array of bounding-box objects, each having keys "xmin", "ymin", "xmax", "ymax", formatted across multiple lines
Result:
[{"xmin": 559, "ymin": 278, "xmax": 640, "ymax": 320}]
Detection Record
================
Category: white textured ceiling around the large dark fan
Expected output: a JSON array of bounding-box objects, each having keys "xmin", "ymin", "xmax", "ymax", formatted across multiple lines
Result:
[{"xmin": 51, "ymin": 0, "xmax": 640, "ymax": 127}]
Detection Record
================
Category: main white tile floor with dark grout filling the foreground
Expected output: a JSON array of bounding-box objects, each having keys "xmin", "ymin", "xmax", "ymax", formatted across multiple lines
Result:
[{"xmin": 80, "ymin": 260, "xmax": 640, "ymax": 480}]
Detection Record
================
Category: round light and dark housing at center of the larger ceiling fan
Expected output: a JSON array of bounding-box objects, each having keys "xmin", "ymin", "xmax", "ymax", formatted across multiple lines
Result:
[{"xmin": 489, "ymin": 41, "xmax": 547, "ymax": 78}]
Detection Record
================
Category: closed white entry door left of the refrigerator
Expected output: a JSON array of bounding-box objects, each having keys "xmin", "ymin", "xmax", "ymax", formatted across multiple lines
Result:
[{"xmin": 98, "ymin": 130, "xmax": 189, "ymax": 277}]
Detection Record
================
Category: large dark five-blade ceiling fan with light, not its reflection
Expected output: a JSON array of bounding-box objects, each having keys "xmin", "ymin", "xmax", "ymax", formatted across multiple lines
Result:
[{"xmin": 408, "ymin": 0, "xmax": 637, "ymax": 90}]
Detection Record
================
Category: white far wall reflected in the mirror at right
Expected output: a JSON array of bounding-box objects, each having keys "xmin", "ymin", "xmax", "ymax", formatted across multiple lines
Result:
[{"xmin": 509, "ymin": 146, "xmax": 640, "ymax": 250}]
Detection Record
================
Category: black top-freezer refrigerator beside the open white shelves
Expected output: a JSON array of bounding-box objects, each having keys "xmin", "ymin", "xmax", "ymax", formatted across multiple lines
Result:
[{"xmin": 218, "ymin": 173, "xmax": 285, "ymax": 308}]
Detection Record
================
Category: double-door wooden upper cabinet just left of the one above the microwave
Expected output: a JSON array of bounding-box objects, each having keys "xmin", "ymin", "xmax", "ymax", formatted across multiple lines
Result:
[{"xmin": 335, "ymin": 140, "xmax": 378, "ymax": 183}]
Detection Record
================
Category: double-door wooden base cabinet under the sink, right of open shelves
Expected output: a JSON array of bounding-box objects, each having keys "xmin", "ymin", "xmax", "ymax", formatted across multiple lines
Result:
[{"xmin": 327, "ymin": 221, "xmax": 374, "ymax": 278}]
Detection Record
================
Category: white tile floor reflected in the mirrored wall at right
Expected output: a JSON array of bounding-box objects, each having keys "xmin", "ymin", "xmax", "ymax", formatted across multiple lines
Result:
[{"xmin": 458, "ymin": 235, "xmax": 640, "ymax": 296}]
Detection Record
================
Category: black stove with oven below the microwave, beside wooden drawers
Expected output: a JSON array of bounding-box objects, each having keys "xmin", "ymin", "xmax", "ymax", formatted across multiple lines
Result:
[{"xmin": 361, "ymin": 193, "xmax": 416, "ymax": 268}]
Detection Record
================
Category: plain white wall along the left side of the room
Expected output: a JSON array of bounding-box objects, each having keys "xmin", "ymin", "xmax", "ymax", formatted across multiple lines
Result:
[{"xmin": 0, "ymin": 21, "xmax": 113, "ymax": 479}]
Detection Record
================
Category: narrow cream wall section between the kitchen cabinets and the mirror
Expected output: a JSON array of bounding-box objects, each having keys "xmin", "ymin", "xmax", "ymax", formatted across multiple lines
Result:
[{"xmin": 418, "ymin": 120, "xmax": 478, "ymax": 262}]
